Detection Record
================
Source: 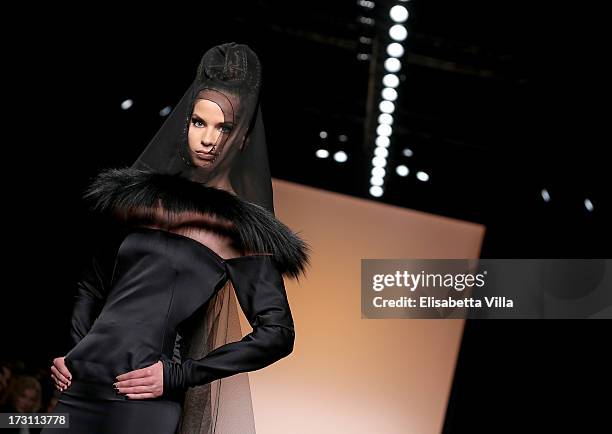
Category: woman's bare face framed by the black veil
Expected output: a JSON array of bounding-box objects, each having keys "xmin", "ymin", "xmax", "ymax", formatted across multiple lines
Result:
[{"xmin": 188, "ymin": 99, "xmax": 233, "ymax": 167}]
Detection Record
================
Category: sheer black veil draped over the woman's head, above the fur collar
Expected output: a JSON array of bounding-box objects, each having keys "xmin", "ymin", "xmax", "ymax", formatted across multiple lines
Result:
[{"xmin": 133, "ymin": 43, "xmax": 274, "ymax": 213}]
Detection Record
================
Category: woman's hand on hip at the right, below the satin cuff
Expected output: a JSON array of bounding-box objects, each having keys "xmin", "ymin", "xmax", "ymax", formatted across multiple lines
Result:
[{"xmin": 113, "ymin": 360, "xmax": 164, "ymax": 399}]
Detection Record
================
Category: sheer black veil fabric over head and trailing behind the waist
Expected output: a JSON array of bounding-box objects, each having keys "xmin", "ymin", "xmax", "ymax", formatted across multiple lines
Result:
[{"xmin": 132, "ymin": 43, "xmax": 274, "ymax": 434}]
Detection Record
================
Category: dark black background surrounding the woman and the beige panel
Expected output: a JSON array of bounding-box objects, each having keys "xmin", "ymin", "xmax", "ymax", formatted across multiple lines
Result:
[{"xmin": 1, "ymin": 0, "xmax": 612, "ymax": 432}]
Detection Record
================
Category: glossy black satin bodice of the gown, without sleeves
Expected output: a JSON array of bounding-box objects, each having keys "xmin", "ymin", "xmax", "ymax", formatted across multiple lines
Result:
[{"xmin": 66, "ymin": 229, "xmax": 226, "ymax": 400}]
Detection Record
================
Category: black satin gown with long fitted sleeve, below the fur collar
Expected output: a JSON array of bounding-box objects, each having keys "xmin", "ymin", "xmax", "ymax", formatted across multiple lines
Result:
[{"xmin": 51, "ymin": 228, "xmax": 295, "ymax": 433}]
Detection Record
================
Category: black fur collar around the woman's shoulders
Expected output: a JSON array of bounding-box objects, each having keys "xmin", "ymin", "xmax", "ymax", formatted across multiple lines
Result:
[{"xmin": 85, "ymin": 167, "xmax": 310, "ymax": 278}]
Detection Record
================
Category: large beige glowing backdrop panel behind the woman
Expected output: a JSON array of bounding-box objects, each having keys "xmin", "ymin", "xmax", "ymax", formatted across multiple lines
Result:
[{"xmin": 241, "ymin": 180, "xmax": 484, "ymax": 434}]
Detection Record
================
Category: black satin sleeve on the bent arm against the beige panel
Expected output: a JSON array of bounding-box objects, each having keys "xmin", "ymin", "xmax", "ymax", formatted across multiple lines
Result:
[{"xmin": 163, "ymin": 255, "xmax": 295, "ymax": 394}]
